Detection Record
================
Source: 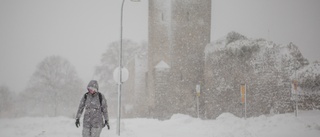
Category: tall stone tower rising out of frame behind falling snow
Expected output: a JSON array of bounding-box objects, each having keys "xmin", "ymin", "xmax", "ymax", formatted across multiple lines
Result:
[{"xmin": 147, "ymin": 0, "xmax": 211, "ymax": 118}]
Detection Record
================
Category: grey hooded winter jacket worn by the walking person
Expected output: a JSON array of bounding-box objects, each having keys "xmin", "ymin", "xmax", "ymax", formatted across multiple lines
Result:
[{"xmin": 76, "ymin": 80, "xmax": 109, "ymax": 128}]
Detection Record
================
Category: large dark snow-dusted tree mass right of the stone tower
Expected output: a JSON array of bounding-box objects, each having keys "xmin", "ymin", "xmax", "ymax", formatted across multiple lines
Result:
[{"xmin": 203, "ymin": 32, "xmax": 308, "ymax": 118}]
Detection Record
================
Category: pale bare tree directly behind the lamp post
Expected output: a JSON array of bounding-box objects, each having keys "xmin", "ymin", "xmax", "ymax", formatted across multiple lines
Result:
[{"xmin": 95, "ymin": 40, "xmax": 146, "ymax": 116}]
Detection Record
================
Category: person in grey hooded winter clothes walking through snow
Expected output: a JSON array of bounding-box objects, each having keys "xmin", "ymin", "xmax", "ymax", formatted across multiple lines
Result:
[{"xmin": 75, "ymin": 80, "xmax": 110, "ymax": 137}]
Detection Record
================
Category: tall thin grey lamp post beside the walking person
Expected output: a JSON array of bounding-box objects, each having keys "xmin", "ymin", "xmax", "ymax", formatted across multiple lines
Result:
[{"xmin": 117, "ymin": 0, "xmax": 140, "ymax": 136}]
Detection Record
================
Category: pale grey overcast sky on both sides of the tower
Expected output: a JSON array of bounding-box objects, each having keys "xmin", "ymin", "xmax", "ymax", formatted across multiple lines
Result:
[{"xmin": 0, "ymin": 0, "xmax": 320, "ymax": 92}]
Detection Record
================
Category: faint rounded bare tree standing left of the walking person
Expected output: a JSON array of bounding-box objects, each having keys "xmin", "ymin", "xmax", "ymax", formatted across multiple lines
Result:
[{"xmin": 22, "ymin": 56, "xmax": 85, "ymax": 116}]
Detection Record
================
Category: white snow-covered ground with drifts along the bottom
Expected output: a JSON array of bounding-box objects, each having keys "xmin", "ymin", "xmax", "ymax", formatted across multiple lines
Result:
[{"xmin": 0, "ymin": 110, "xmax": 320, "ymax": 137}]
